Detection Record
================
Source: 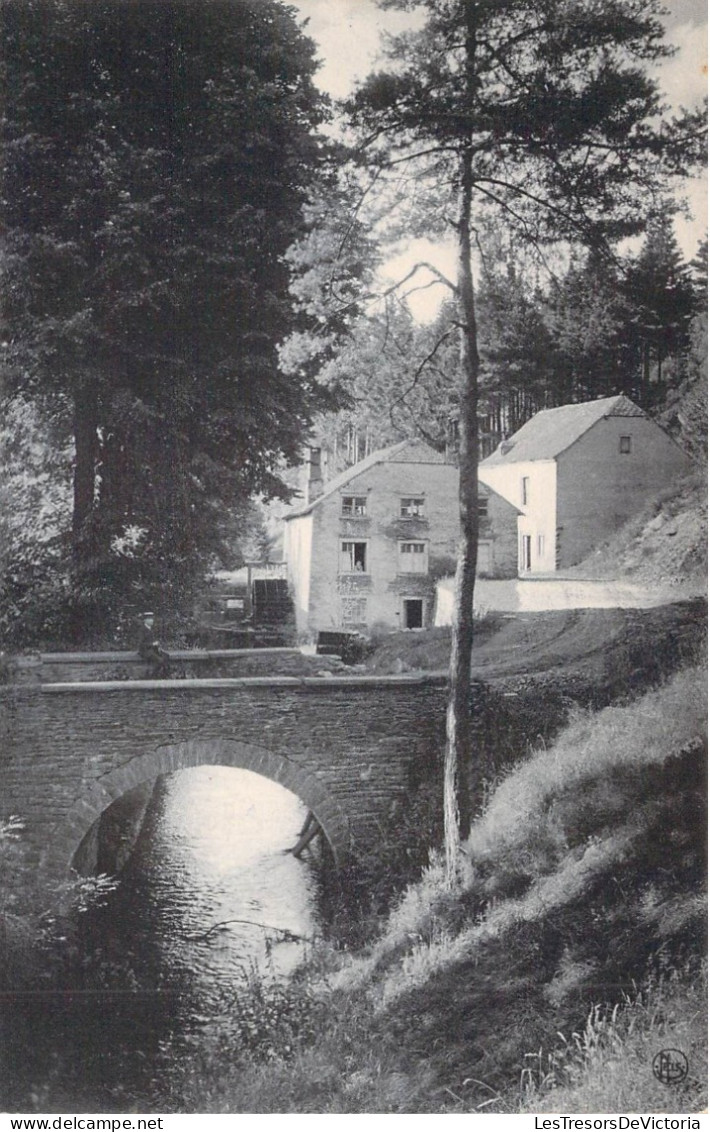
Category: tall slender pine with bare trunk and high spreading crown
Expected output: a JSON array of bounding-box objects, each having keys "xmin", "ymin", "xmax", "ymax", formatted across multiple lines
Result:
[{"xmin": 350, "ymin": 0, "xmax": 703, "ymax": 882}]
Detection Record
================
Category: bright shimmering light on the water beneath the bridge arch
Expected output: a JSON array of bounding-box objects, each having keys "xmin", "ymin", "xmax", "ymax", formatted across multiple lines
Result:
[{"xmin": 108, "ymin": 766, "xmax": 316, "ymax": 998}]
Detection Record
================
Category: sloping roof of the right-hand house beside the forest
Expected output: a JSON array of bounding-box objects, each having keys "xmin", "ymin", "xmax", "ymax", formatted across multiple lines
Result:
[{"xmin": 481, "ymin": 394, "xmax": 647, "ymax": 468}]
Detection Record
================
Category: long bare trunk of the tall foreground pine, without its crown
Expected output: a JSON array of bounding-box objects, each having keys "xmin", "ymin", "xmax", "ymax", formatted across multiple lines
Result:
[{"xmin": 444, "ymin": 136, "xmax": 479, "ymax": 886}]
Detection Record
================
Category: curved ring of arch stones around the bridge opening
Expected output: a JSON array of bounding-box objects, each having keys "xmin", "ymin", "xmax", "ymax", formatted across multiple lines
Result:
[{"xmin": 44, "ymin": 739, "xmax": 352, "ymax": 873}]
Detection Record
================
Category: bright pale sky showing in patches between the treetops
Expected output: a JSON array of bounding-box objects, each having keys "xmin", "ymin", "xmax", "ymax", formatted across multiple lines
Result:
[{"xmin": 289, "ymin": 0, "xmax": 708, "ymax": 318}]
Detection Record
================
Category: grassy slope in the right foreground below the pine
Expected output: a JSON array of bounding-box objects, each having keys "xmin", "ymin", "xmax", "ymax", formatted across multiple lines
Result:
[{"xmin": 165, "ymin": 669, "xmax": 705, "ymax": 1113}]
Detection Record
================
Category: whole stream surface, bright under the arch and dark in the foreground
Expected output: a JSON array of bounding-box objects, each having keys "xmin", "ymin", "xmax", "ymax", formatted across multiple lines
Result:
[{"xmin": 29, "ymin": 766, "xmax": 319, "ymax": 1112}]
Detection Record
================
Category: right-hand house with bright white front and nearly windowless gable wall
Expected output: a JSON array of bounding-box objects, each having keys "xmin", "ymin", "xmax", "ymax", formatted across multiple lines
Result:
[{"xmin": 479, "ymin": 395, "xmax": 693, "ymax": 575}]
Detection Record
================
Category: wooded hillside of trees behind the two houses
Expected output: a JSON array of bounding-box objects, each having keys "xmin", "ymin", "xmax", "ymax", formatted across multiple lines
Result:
[{"xmin": 316, "ymin": 212, "xmax": 707, "ymax": 462}]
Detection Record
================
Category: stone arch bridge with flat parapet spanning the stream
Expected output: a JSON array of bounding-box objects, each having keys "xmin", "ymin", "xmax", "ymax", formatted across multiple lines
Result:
[{"xmin": 0, "ymin": 654, "xmax": 446, "ymax": 874}]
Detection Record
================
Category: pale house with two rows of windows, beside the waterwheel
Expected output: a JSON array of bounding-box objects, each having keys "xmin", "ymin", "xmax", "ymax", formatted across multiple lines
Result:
[{"xmin": 284, "ymin": 440, "xmax": 517, "ymax": 636}]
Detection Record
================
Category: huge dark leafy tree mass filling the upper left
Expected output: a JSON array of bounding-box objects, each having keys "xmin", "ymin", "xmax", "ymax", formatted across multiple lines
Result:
[{"xmin": 0, "ymin": 0, "xmax": 339, "ymax": 638}]
